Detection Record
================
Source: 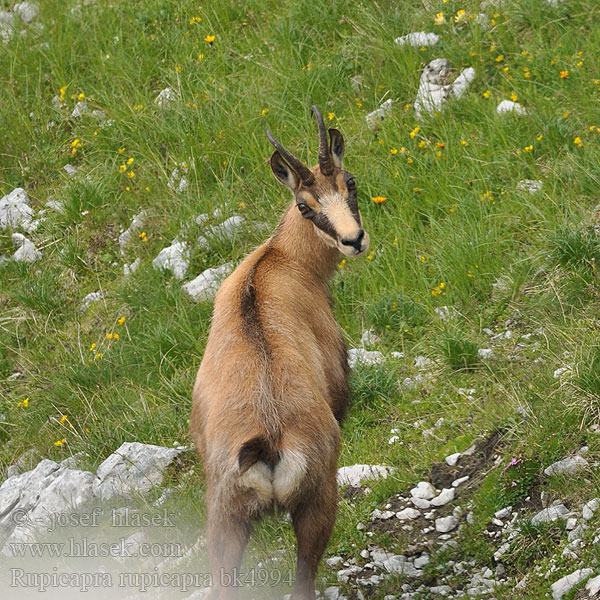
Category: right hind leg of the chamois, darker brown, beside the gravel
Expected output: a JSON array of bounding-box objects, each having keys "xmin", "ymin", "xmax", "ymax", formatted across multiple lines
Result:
[{"xmin": 290, "ymin": 475, "xmax": 337, "ymax": 600}]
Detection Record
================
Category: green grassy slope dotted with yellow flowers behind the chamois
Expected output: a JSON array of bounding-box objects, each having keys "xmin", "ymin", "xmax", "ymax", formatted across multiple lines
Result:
[{"xmin": 0, "ymin": 0, "xmax": 600, "ymax": 600}]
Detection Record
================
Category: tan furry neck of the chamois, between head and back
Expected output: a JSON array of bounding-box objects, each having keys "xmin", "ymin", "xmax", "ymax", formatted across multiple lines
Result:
[{"xmin": 271, "ymin": 201, "xmax": 340, "ymax": 284}]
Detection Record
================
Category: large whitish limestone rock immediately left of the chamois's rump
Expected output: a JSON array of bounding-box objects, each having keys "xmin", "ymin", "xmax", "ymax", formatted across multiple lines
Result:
[{"xmin": 94, "ymin": 442, "xmax": 183, "ymax": 500}]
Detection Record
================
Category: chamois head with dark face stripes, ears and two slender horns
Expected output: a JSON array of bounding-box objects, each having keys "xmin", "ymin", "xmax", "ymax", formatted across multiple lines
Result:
[{"xmin": 267, "ymin": 106, "xmax": 369, "ymax": 257}]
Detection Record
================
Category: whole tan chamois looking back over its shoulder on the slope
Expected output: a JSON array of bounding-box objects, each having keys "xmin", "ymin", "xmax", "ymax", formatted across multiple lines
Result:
[{"xmin": 190, "ymin": 106, "xmax": 369, "ymax": 600}]
